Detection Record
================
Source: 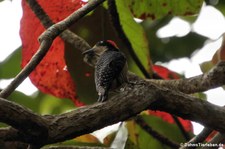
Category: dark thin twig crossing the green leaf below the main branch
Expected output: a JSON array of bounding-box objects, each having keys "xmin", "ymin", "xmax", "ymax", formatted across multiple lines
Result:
[{"xmin": 135, "ymin": 116, "xmax": 180, "ymax": 148}]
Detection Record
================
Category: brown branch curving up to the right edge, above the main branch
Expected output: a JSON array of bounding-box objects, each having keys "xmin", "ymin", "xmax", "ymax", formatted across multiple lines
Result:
[{"xmin": 148, "ymin": 61, "xmax": 225, "ymax": 94}]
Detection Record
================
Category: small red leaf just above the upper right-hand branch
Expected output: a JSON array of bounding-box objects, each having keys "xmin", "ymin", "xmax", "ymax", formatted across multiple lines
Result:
[{"xmin": 153, "ymin": 65, "xmax": 180, "ymax": 80}]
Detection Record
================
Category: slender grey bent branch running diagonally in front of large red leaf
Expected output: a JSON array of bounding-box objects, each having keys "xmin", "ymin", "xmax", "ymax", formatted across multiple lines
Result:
[{"xmin": 0, "ymin": 0, "xmax": 105, "ymax": 98}]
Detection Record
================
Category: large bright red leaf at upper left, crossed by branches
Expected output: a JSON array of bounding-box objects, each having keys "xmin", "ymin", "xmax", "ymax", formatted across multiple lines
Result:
[{"xmin": 20, "ymin": 0, "xmax": 85, "ymax": 106}]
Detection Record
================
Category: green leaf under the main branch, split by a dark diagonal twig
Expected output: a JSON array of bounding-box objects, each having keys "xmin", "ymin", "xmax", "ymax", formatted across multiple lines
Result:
[{"xmin": 127, "ymin": 115, "xmax": 192, "ymax": 149}]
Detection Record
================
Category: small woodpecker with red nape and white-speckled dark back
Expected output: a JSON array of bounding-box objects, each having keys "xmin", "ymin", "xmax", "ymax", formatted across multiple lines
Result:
[{"xmin": 83, "ymin": 40, "xmax": 128, "ymax": 102}]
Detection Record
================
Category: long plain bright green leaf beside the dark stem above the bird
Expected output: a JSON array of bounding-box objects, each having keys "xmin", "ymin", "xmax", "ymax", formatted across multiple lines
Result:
[{"xmin": 116, "ymin": 0, "xmax": 151, "ymax": 73}]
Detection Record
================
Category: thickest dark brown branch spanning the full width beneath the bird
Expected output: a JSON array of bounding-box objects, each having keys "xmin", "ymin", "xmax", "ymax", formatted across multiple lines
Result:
[{"xmin": 0, "ymin": 74, "xmax": 225, "ymax": 145}]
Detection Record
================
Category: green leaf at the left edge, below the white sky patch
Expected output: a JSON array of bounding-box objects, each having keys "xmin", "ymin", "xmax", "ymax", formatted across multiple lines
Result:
[{"xmin": 0, "ymin": 47, "xmax": 21, "ymax": 79}]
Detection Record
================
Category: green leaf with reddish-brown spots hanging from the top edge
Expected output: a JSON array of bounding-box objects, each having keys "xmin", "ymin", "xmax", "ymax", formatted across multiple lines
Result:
[{"xmin": 126, "ymin": 0, "xmax": 203, "ymax": 20}]
